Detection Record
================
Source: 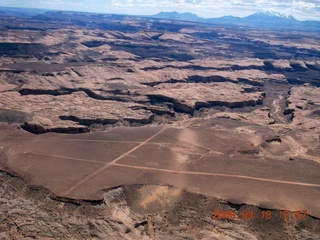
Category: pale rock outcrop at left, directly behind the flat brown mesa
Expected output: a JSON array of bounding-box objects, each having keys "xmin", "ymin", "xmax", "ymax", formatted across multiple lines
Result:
[{"xmin": 0, "ymin": 92, "xmax": 154, "ymax": 133}]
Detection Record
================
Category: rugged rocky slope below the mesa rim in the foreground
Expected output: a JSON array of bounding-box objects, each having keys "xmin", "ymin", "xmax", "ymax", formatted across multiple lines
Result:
[{"xmin": 0, "ymin": 172, "xmax": 319, "ymax": 240}]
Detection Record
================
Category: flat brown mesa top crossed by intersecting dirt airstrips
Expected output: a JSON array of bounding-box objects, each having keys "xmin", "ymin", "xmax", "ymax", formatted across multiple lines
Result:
[{"xmin": 0, "ymin": 127, "xmax": 320, "ymax": 217}]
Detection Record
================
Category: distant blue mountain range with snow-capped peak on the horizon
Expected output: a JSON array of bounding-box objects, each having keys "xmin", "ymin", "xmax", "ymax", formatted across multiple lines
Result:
[{"xmin": 149, "ymin": 11, "xmax": 320, "ymax": 30}]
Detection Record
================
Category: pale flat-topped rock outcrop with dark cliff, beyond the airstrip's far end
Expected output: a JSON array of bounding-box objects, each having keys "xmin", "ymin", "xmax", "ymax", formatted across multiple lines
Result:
[{"xmin": 148, "ymin": 82, "xmax": 265, "ymax": 115}]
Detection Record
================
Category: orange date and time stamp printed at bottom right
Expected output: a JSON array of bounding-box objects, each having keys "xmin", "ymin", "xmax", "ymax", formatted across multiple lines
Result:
[{"xmin": 212, "ymin": 210, "xmax": 307, "ymax": 220}]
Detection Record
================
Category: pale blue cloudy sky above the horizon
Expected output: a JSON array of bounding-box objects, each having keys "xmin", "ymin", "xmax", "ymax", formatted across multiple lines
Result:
[{"xmin": 0, "ymin": 0, "xmax": 320, "ymax": 20}]
